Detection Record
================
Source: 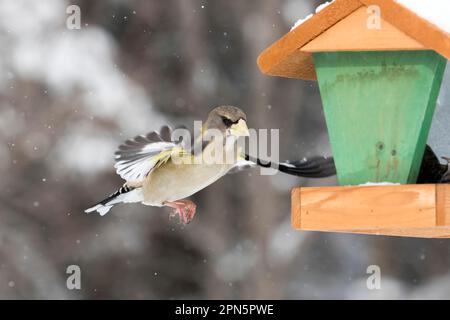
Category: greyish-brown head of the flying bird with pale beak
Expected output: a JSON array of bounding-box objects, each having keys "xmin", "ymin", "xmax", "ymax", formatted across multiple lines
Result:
[{"xmin": 203, "ymin": 106, "xmax": 250, "ymax": 137}]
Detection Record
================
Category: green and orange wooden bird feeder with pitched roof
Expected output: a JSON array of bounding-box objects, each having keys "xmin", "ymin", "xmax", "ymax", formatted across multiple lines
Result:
[{"xmin": 258, "ymin": 0, "xmax": 450, "ymax": 238}]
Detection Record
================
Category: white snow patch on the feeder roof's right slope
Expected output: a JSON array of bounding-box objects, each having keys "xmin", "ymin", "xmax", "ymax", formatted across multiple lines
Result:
[{"xmin": 396, "ymin": 0, "xmax": 450, "ymax": 33}]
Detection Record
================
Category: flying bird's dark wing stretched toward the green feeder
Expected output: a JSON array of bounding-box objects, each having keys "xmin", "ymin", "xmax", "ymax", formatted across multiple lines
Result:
[{"xmin": 230, "ymin": 154, "xmax": 336, "ymax": 178}]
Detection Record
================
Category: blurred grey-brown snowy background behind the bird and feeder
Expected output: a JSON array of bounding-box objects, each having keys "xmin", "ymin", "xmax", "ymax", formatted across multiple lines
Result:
[{"xmin": 0, "ymin": 0, "xmax": 450, "ymax": 299}]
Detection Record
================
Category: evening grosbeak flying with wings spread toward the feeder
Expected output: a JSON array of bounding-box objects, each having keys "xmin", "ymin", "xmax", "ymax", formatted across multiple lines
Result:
[{"xmin": 85, "ymin": 106, "xmax": 335, "ymax": 224}]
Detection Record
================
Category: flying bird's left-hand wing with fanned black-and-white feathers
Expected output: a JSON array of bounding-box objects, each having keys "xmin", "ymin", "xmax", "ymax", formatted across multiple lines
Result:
[{"xmin": 114, "ymin": 126, "xmax": 184, "ymax": 183}]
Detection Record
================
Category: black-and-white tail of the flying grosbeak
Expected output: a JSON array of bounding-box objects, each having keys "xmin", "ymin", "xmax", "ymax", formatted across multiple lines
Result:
[{"xmin": 84, "ymin": 185, "xmax": 143, "ymax": 216}]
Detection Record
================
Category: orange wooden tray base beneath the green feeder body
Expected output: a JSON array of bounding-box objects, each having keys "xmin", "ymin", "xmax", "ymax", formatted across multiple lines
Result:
[{"xmin": 292, "ymin": 184, "xmax": 450, "ymax": 238}]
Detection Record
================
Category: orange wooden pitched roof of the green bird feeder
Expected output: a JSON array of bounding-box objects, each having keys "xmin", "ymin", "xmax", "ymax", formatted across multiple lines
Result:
[{"xmin": 258, "ymin": 0, "xmax": 450, "ymax": 80}]
